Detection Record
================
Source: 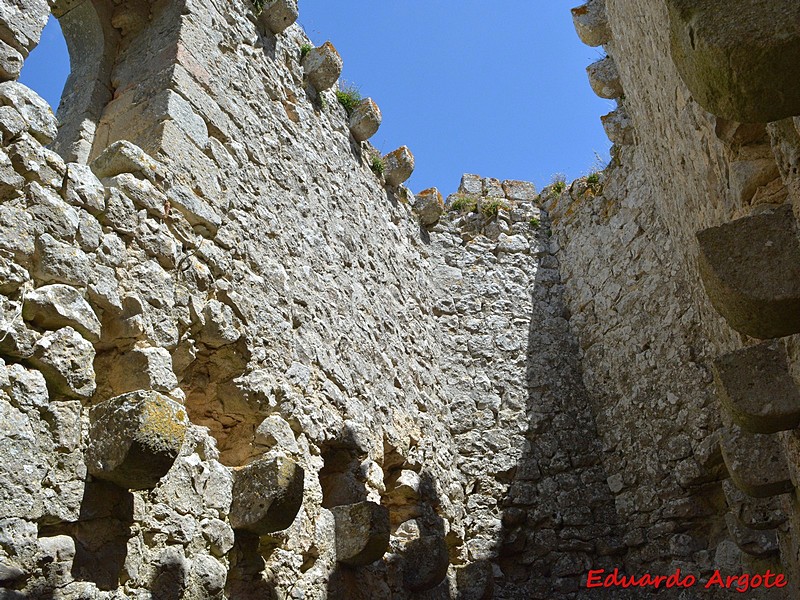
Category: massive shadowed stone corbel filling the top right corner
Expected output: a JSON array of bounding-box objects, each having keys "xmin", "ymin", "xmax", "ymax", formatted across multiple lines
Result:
[{"xmin": 667, "ymin": 0, "xmax": 800, "ymax": 123}]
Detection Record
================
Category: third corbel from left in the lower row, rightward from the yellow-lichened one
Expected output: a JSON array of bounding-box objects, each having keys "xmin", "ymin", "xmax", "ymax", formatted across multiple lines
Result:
[{"xmin": 330, "ymin": 502, "xmax": 389, "ymax": 567}]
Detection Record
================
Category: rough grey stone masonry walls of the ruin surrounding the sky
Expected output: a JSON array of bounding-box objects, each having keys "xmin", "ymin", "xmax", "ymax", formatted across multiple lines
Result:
[{"xmin": 0, "ymin": 0, "xmax": 800, "ymax": 600}]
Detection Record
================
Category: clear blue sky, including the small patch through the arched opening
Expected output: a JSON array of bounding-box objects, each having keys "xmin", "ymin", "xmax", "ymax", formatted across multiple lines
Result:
[{"xmin": 22, "ymin": 0, "xmax": 614, "ymax": 194}]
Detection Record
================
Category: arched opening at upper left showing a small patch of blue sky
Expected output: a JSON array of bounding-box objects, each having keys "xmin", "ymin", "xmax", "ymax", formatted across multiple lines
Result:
[{"xmin": 19, "ymin": 16, "xmax": 70, "ymax": 112}]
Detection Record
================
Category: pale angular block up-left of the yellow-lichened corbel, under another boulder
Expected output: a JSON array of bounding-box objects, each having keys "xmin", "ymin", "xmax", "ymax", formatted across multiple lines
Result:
[{"xmin": 30, "ymin": 327, "xmax": 96, "ymax": 399}]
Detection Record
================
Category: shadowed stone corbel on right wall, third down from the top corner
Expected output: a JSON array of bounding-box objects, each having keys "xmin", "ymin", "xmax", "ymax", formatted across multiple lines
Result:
[{"xmin": 713, "ymin": 342, "xmax": 800, "ymax": 433}]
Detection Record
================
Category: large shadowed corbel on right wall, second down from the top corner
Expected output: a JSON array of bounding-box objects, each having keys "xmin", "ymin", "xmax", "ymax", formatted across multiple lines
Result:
[{"xmin": 697, "ymin": 205, "xmax": 800, "ymax": 339}]
